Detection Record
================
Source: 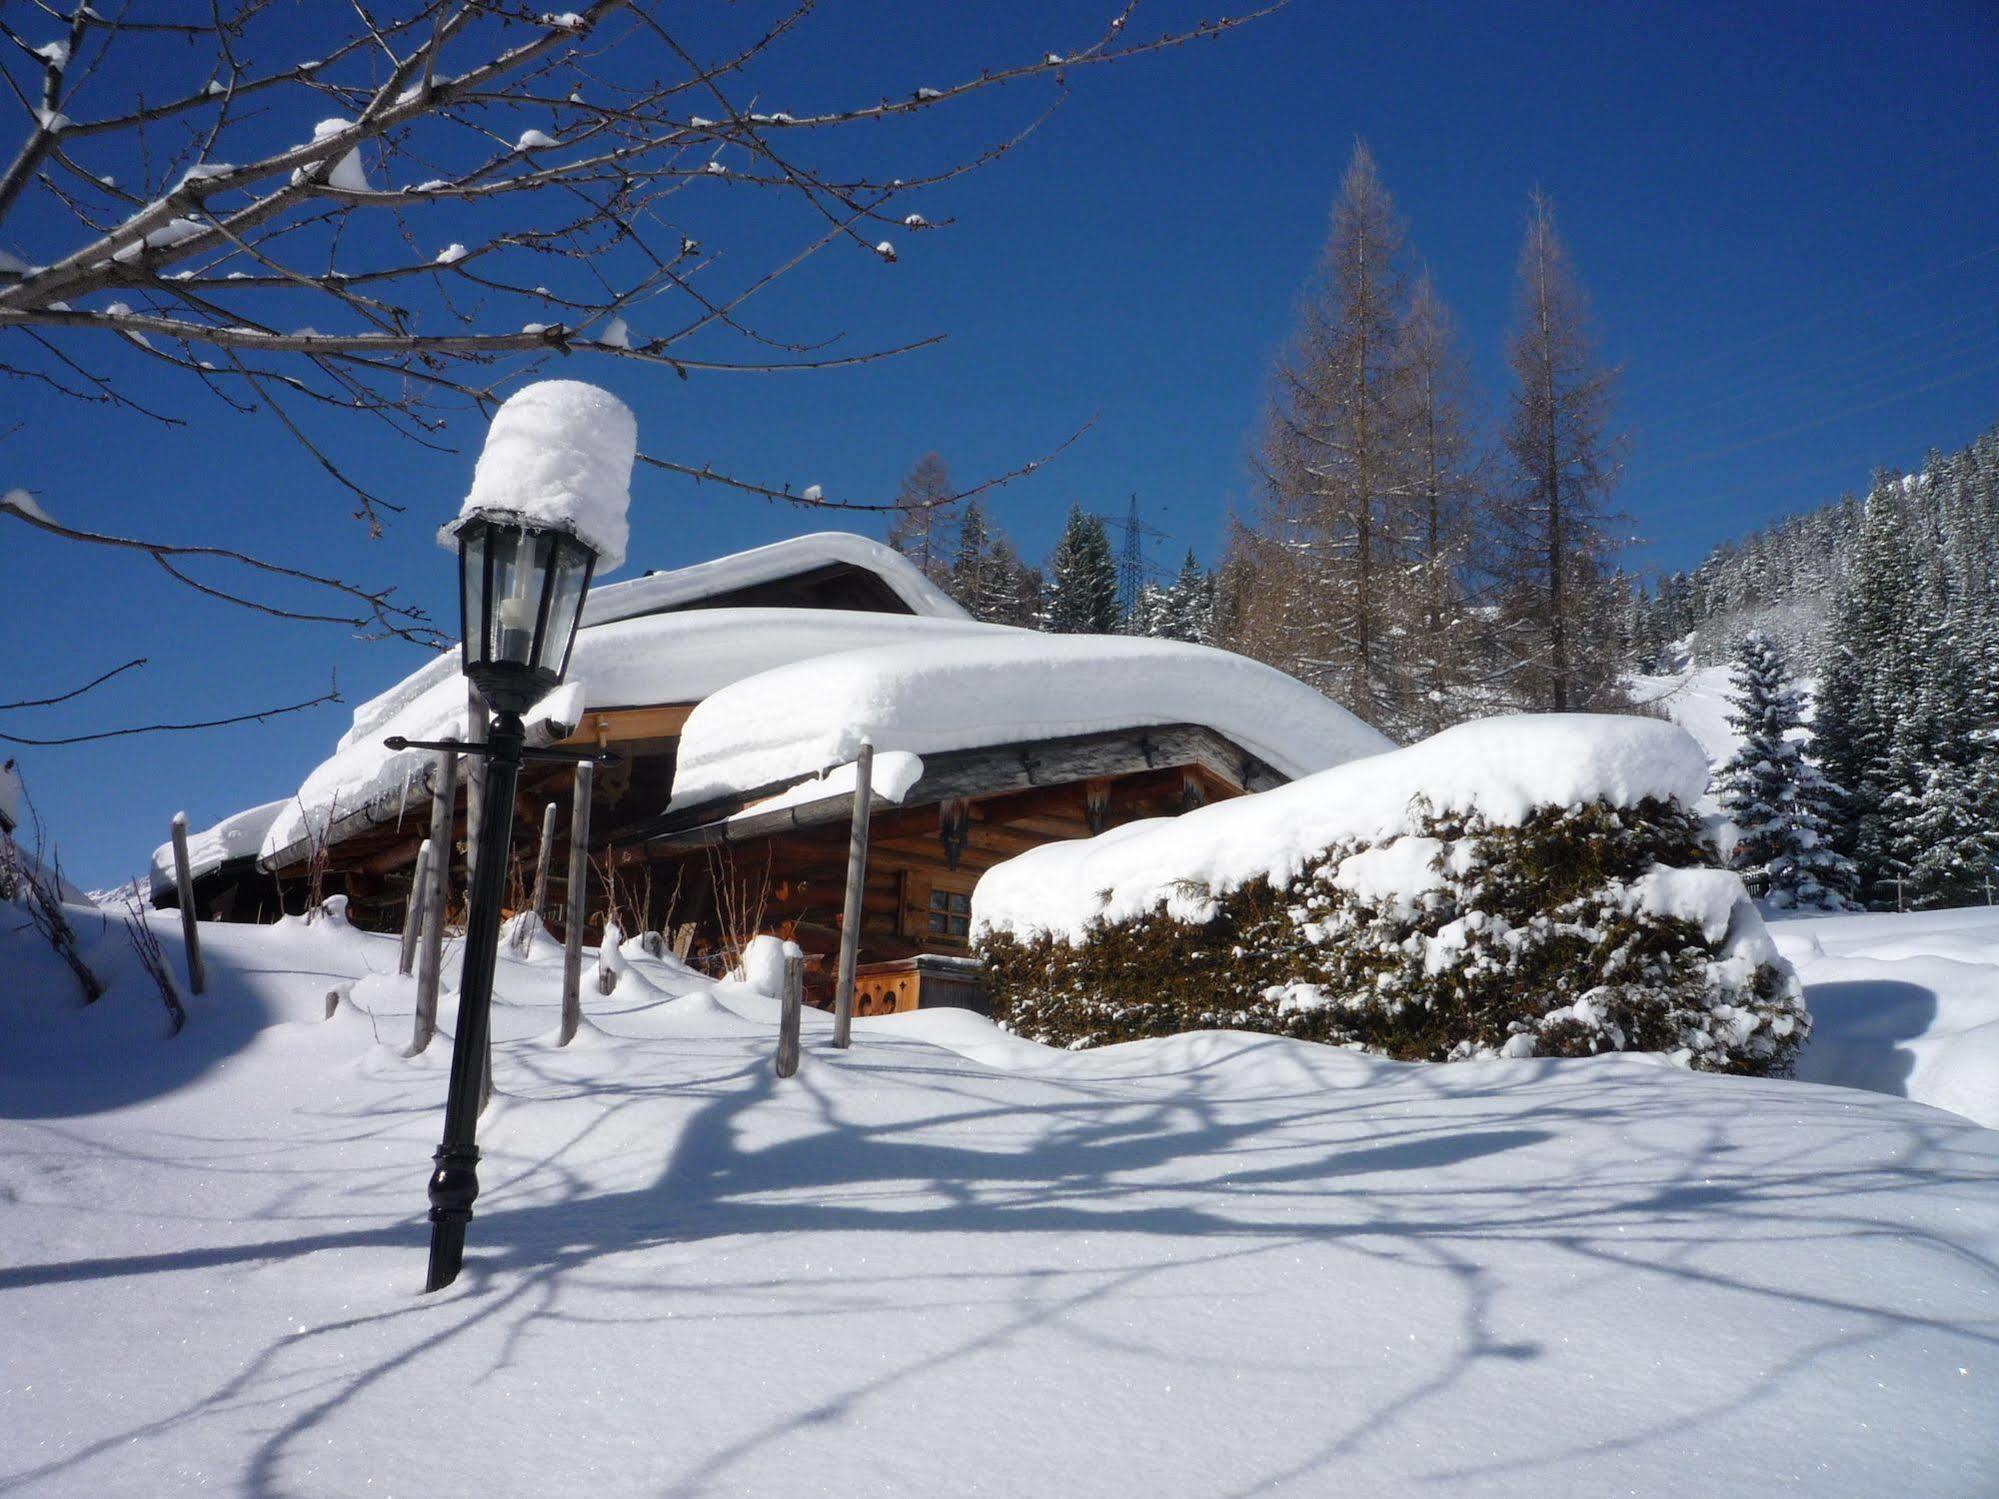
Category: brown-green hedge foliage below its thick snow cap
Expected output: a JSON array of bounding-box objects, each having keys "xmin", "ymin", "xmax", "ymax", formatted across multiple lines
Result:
[{"xmin": 980, "ymin": 799, "xmax": 1811, "ymax": 1073}]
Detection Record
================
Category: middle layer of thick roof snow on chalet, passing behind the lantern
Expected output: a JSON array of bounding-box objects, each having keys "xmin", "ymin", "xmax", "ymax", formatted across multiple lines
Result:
[{"xmin": 262, "ymin": 610, "xmax": 1019, "ymax": 857}]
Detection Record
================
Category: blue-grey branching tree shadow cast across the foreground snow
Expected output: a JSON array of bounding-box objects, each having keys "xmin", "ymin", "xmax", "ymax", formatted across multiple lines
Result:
[{"xmin": 0, "ymin": 1023, "xmax": 1999, "ymax": 1495}]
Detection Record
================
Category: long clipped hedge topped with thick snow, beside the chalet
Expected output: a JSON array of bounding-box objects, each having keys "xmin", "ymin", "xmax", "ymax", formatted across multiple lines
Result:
[{"xmin": 974, "ymin": 716, "xmax": 1809, "ymax": 1073}]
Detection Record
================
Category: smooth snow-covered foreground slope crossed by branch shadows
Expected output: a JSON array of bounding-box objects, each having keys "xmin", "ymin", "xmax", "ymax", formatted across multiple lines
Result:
[{"xmin": 0, "ymin": 899, "xmax": 1999, "ymax": 1495}]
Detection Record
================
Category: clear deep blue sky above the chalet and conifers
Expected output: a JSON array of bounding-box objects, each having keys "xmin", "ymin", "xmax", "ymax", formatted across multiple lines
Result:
[{"xmin": 0, "ymin": 0, "xmax": 1999, "ymax": 883}]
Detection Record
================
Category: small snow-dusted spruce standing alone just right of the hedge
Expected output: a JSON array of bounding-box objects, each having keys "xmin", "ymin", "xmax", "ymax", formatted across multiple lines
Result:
[{"xmin": 1719, "ymin": 632, "xmax": 1853, "ymax": 911}]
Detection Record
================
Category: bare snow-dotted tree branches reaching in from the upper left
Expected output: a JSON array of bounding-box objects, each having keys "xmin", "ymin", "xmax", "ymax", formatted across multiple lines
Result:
[{"xmin": 0, "ymin": 0, "xmax": 1245, "ymax": 744}]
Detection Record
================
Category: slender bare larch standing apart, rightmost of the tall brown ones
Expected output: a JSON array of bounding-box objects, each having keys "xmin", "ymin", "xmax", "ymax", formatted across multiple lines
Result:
[{"xmin": 1491, "ymin": 192, "xmax": 1619, "ymax": 714}]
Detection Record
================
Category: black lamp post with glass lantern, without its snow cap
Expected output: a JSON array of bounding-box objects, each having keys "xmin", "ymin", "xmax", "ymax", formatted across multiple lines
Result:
[{"xmin": 388, "ymin": 516, "xmax": 604, "ymax": 1291}]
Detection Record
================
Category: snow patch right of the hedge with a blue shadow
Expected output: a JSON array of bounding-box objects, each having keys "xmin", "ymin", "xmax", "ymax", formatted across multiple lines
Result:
[{"xmin": 1769, "ymin": 905, "xmax": 1999, "ymax": 1129}]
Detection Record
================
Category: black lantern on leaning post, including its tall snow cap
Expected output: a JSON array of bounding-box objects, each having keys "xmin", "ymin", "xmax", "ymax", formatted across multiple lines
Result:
[{"xmin": 388, "ymin": 380, "xmax": 638, "ymax": 1291}]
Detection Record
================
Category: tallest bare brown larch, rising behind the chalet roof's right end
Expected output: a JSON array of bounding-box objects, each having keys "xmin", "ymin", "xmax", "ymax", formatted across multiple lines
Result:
[{"xmin": 1239, "ymin": 144, "xmax": 1415, "ymax": 732}]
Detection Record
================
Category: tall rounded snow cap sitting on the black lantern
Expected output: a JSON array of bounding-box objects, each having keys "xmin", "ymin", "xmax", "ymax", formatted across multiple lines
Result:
[{"xmin": 440, "ymin": 380, "xmax": 638, "ymax": 574}]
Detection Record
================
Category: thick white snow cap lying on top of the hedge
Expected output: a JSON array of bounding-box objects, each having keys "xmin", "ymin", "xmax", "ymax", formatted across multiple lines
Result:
[{"xmin": 975, "ymin": 714, "xmax": 1707, "ymax": 939}]
